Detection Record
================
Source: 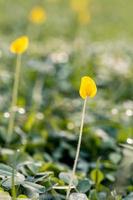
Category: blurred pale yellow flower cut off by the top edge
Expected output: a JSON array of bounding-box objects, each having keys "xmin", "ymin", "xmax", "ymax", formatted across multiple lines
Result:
[{"xmin": 70, "ymin": 0, "xmax": 90, "ymax": 12}]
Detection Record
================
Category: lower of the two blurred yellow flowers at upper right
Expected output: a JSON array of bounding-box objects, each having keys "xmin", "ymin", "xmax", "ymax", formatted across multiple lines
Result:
[{"xmin": 78, "ymin": 10, "xmax": 91, "ymax": 25}]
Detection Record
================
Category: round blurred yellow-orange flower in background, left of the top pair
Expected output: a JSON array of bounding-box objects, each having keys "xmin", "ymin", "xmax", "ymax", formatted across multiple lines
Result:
[{"xmin": 29, "ymin": 6, "xmax": 47, "ymax": 24}]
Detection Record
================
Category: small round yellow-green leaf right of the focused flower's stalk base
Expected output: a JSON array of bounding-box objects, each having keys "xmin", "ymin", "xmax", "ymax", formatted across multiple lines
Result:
[{"xmin": 90, "ymin": 169, "xmax": 104, "ymax": 184}]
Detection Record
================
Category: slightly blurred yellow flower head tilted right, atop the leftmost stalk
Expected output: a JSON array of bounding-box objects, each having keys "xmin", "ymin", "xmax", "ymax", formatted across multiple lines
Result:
[{"xmin": 10, "ymin": 36, "xmax": 29, "ymax": 54}]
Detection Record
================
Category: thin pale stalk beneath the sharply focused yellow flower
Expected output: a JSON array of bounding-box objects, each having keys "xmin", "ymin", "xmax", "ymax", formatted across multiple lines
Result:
[{"xmin": 66, "ymin": 98, "xmax": 87, "ymax": 200}]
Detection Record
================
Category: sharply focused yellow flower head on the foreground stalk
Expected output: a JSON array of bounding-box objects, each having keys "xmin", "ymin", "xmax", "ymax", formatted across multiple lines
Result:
[{"xmin": 79, "ymin": 76, "xmax": 97, "ymax": 99}]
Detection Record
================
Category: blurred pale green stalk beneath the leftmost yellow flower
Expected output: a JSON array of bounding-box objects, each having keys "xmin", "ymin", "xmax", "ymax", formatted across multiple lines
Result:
[{"xmin": 7, "ymin": 54, "xmax": 21, "ymax": 143}]
